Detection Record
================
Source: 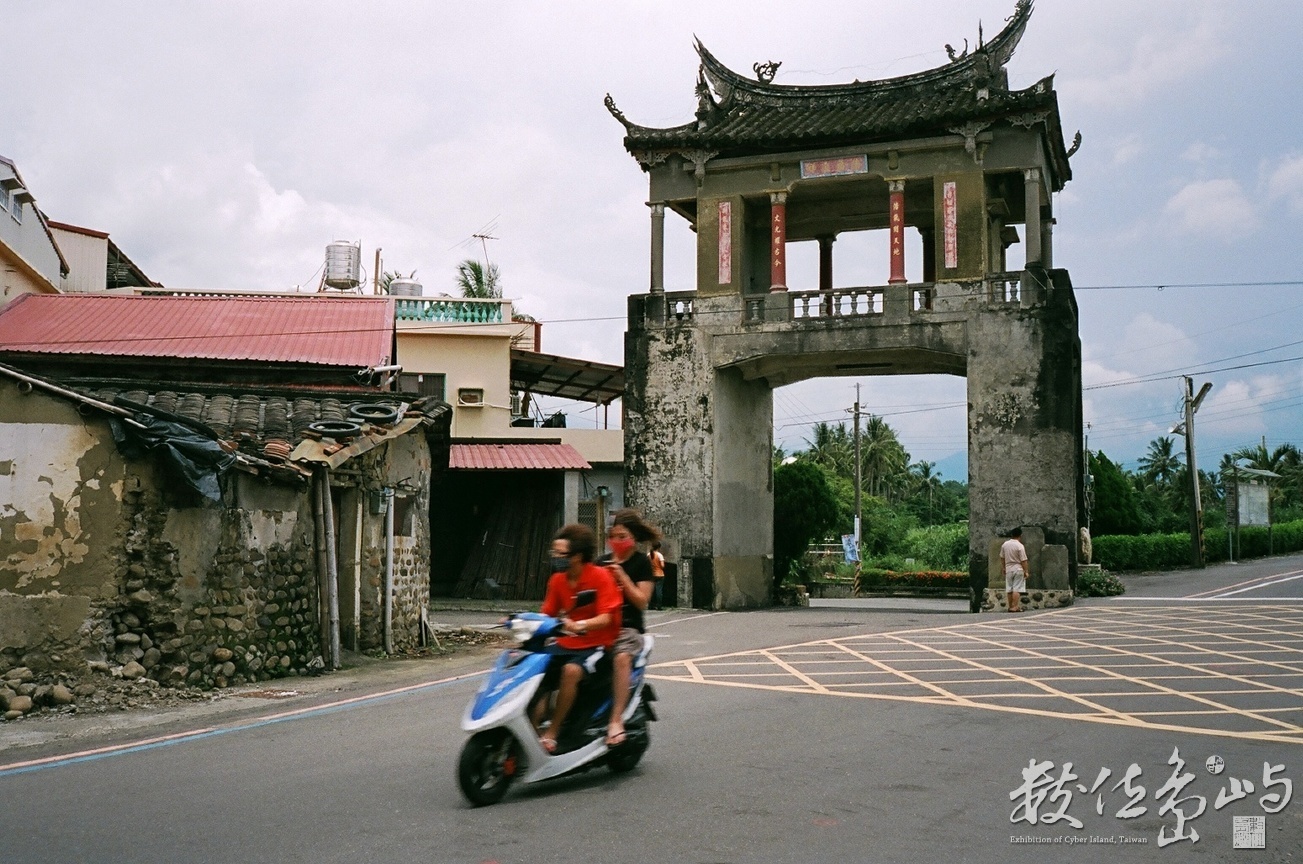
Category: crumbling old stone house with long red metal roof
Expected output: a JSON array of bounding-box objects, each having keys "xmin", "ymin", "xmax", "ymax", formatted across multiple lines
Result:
[{"xmin": 0, "ymin": 295, "xmax": 450, "ymax": 708}]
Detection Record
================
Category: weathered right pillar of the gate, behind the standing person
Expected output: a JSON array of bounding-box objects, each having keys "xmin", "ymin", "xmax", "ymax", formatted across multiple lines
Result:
[{"xmin": 967, "ymin": 268, "xmax": 1084, "ymax": 611}]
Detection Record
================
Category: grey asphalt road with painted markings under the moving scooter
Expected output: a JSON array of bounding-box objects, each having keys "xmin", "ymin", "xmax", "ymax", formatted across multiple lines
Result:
[{"xmin": 0, "ymin": 556, "xmax": 1303, "ymax": 864}]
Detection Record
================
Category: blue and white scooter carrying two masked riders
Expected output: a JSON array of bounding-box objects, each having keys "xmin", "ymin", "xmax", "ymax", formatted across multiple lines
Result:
[{"xmin": 457, "ymin": 612, "xmax": 655, "ymax": 807}]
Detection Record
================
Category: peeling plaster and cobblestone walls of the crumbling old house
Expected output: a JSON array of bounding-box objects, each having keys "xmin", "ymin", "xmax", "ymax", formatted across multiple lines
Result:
[{"xmin": 0, "ymin": 379, "xmax": 430, "ymax": 687}]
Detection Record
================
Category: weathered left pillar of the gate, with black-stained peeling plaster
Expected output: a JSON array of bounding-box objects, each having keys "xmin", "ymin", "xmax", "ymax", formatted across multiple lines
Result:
[{"xmin": 624, "ymin": 293, "xmax": 774, "ymax": 609}]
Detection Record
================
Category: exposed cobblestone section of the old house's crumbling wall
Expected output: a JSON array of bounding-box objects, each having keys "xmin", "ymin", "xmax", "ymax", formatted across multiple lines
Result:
[{"xmin": 86, "ymin": 478, "xmax": 321, "ymax": 687}]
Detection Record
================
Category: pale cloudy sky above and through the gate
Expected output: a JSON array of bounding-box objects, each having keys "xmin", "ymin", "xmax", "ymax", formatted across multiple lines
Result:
[{"xmin": 0, "ymin": 0, "xmax": 1303, "ymax": 478}]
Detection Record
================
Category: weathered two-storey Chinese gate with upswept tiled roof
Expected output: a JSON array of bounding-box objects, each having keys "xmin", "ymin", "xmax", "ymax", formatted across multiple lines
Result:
[{"xmin": 607, "ymin": 0, "xmax": 1083, "ymax": 609}]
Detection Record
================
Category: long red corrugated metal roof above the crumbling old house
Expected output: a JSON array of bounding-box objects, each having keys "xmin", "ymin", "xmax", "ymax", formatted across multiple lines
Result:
[{"xmin": 0, "ymin": 295, "xmax": 394, "ymax": 367}]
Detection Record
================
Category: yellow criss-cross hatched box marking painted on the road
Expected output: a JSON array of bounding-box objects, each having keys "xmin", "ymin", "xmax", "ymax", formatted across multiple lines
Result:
[{"xmin": 649, "ymin": 602, "xmax": 1303, "ymax": 743}]
